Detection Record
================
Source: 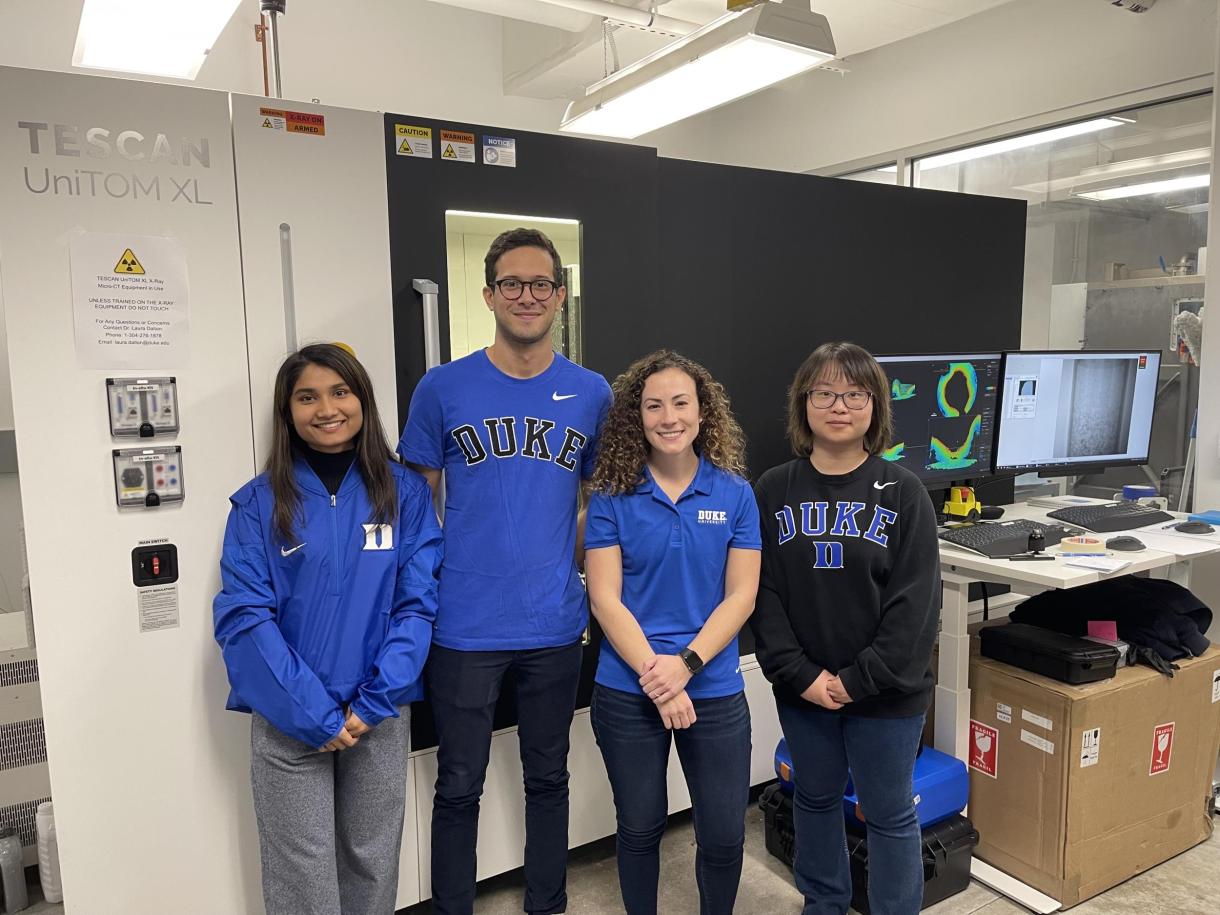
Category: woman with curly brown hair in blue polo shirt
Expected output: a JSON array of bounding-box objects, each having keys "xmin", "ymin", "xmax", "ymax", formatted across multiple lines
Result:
[{"xmin": 584, "ymin": 350, "xmax": 761, "ymax": 915}]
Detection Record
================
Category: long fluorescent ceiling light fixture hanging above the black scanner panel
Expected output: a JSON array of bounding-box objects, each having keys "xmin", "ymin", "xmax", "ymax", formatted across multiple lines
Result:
[{"xmin": 559, "ymin": 0, "xmax": 834, "ymax": 139}]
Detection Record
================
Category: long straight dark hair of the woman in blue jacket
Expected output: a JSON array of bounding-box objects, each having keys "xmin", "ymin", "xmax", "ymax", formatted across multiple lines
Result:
[{"xmin": 267, "ymin": 343, "xmax": 398, "ymax": 542}]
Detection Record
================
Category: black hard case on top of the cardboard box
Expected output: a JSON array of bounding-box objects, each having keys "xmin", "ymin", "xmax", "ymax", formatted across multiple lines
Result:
[{"xmin": 978, "ymin": 622, "xmax": 1119, "ymax": 686}]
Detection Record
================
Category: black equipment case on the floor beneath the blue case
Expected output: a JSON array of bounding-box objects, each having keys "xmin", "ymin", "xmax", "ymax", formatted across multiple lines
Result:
[{"xmin": 759, "ymin": 784, "xmax": 978, "ymax": 915}]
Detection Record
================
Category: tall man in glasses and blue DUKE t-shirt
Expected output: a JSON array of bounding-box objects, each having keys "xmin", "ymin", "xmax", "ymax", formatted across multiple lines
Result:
[{"xmin": 400, "ymin": 228, "xmax": 610, "ymax": 915}]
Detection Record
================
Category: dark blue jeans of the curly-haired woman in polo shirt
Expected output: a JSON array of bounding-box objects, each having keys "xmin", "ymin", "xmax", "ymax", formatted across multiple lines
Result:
[{"xmin": 592, "ymin": 683, "xmax": 750, "ymax": 915}]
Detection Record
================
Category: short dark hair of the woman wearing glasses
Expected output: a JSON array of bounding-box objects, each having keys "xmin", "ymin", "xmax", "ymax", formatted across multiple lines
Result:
[{"xmin": 788, "ymin": 343, "xmax": 893, "ymax": 458}]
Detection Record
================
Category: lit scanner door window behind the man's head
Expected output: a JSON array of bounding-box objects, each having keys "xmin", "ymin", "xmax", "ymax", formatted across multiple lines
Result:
[{"xmin": 445, "ymin": 211, "xmax": 582, "ymax": 364}]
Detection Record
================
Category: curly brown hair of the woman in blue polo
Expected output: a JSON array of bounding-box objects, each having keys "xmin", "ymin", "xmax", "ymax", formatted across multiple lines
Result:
[{"xmin": 593, "ymin": 349, "xmax": 745, "ymax": 495}]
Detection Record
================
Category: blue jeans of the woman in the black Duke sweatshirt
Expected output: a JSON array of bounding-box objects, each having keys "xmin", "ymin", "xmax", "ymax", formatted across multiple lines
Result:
[{"xmin": 777, "ymin": 703, "xmax": 924, "ymax": 915}]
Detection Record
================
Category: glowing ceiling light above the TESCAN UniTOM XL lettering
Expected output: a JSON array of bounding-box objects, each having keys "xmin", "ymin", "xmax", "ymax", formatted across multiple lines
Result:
[{"xmin": 72, "ymin": 0, "xmax": 240, "ymax": 79}]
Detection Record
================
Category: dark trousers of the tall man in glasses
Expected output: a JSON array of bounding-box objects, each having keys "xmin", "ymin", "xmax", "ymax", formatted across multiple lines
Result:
[{"xmin": 427, "ymin": 642, "xmax": 581, "ymax": 915}]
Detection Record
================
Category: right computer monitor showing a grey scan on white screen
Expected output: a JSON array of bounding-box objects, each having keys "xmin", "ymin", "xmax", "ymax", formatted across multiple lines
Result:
[{"xmin": 996, "ymin": 349, "xmax": 1160, "ymax": 475}]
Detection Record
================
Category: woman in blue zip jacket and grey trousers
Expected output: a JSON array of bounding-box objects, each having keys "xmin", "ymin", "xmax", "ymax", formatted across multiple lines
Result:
[{"xmin": 212, "ymin": 344, "xmax": 442, "ymax": 915}]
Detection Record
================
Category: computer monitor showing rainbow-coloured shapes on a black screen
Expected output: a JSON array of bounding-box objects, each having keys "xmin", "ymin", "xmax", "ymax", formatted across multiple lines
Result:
[{"xmin": 877, "ymin": 353, "xmax": 1000, "ymax": 488}]
